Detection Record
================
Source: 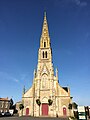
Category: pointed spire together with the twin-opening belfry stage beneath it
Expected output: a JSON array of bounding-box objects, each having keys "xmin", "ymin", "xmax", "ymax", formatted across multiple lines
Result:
[{"xmin": 38, "ymin": 12, "xmax": 52, "ymax": 64}]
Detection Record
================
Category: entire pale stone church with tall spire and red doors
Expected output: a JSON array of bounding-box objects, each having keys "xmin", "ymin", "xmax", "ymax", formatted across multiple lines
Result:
[{"xmin": 22, "ymin": 13, "xmax": 72, "ymax": 117}]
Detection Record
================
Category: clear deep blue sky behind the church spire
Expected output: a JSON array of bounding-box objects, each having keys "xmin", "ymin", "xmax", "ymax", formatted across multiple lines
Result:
[{"xmin": 0, "ymin": 0, "xmax": 90, "ymax": 105}]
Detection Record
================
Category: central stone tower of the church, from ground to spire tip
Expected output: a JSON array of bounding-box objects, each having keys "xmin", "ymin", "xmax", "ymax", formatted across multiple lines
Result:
[{"xmin": 34, "ymin": 12, "xmax": 58, "ymax": 116}]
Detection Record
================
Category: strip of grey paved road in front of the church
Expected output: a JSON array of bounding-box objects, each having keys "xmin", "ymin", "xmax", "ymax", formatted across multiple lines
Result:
[{"xmin": 0, "ymin": 116, "xmax": 68, "ymax": 120}]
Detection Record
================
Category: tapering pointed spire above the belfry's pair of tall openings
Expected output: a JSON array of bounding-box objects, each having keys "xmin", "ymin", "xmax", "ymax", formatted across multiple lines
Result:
[{"xmin": 40, "ymin": 12, "xmax": 50, "ymax": 48}]
